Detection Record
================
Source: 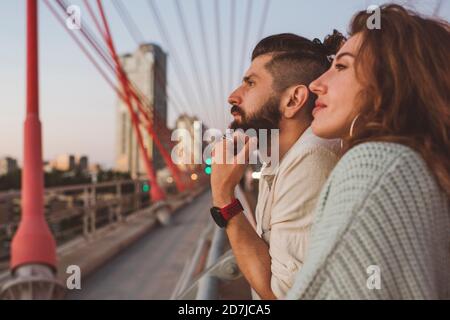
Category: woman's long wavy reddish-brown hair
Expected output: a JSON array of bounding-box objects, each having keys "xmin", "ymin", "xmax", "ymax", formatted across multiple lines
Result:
[{"xmin": 347, "ymin": 4, "xmax": 450, "ymax": 195}]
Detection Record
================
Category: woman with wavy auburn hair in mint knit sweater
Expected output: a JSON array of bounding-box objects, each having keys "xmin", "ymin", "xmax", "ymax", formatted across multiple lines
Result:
[{"xmin": 287, "ymin": 5, "xmax": 450, "ymax": 299}]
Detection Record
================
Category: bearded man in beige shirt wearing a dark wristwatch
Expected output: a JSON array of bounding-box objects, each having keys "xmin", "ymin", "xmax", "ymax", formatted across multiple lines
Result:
[{"xmin": 211, "ymin": 31, "xmax": 344, "ymax": 299}]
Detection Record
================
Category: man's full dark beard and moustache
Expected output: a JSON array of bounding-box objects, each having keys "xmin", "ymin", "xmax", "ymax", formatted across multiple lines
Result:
[{"xmin": 230, "ymin": 96, "xmax": 281, "ymax": 135}]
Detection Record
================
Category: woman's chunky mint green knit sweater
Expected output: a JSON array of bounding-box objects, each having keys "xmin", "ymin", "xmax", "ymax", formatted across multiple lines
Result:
[{"xmin": 287, "ymin": 143, "xmax": 450, "ymax": 299}]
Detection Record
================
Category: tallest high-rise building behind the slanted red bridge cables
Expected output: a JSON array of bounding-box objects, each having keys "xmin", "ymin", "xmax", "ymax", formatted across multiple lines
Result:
[{"xmin": 116, "ymin": 44, "xmax": 167, "ymax": 178}]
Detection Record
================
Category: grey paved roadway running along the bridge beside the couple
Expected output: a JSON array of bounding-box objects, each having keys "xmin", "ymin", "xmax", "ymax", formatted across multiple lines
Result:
[{"xmin": 67, "ymin": 192, "xmax": 211, "ymax": 300}]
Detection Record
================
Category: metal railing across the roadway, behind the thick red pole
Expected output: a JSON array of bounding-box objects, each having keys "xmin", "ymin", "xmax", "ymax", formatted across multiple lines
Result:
[{"xmin": 0, "ymin": 180, "xmax": 161, "ymax": 261}]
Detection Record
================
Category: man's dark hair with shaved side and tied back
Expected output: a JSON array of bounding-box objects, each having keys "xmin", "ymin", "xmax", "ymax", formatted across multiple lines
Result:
[{"xmin": 252, "ymin": 30, "xmax": 345, "ymax": 113}]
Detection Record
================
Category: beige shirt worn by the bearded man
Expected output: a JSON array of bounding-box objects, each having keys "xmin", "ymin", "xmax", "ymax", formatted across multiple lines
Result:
[{"xmin": 255, "ymin": 128, "xmax": 340, "ymax": 298}]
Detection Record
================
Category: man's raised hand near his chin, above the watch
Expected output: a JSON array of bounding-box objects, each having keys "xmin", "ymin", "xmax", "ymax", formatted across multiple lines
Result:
[{"xmin": 211, "ymin": 134, "xmax": 253, "ymax": 208}]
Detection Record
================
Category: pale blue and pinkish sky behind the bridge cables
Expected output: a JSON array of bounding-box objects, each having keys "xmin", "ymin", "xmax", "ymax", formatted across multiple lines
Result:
[{"xmin": 0, "ymin": 0, "xmax": 450, "ymax": 167}]
